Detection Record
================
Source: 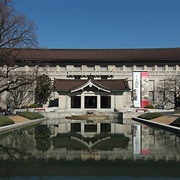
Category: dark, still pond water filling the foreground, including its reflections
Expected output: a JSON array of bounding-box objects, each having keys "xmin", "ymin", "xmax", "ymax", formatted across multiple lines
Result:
[{"xmin": 0, "ymin": 121, "xmax": 180, "ymax": 180}]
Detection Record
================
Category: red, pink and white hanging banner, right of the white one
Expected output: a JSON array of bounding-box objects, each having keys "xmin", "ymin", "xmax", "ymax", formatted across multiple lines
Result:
[{"xmin": 141, "ymin": 72, "xmax": 149, "ymax": 107}]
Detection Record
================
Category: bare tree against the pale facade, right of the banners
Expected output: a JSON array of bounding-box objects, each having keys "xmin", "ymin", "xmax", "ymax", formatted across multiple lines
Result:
[{"xmin": 156, "ymin": 74, "xmax": 180, "ymax": 109}]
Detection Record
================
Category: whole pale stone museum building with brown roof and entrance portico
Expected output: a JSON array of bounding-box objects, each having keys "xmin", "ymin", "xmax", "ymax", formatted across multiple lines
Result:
[{"xmin": 12, "ymin": 48, "xmax": 180, "ymax": 110}]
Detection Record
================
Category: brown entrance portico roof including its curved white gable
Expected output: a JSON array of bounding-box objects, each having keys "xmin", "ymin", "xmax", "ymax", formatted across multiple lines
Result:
[{"xmin": 53, "ymin": 78, "xmax": 130, "ymax": 92}]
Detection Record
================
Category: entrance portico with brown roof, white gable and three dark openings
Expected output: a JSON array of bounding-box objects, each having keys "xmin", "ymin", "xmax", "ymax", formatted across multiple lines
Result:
[{"xmin": 54, "ymin": 78, "xmax": 130, "ymax": 110}]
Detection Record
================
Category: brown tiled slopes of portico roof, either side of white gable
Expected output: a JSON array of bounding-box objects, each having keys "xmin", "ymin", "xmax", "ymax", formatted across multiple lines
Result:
[{"xmin": 53, "ymin": 79, "xmax": 130, "ymax": 91}]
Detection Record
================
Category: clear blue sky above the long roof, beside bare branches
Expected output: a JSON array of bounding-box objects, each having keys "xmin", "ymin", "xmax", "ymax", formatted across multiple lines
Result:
[{"xmin": 14, "ymin": 0, "xmax": 180, "ymax": 49}]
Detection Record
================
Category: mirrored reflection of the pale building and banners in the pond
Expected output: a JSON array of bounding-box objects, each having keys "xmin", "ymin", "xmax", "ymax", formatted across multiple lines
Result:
[{"xmin": 0, "ymin": 122, "xmax": 180, "ymax": 161}]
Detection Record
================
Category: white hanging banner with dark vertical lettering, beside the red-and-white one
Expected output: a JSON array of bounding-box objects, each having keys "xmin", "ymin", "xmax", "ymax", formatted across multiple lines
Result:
[{"xmin": 133, "ymin": 72, "xmax": 141, "ymax": 107}]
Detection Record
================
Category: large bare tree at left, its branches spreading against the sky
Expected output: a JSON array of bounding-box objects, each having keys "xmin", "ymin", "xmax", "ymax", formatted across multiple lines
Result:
[{"xmin": 0, "ymin": 0, "xmax": 38, "ymax": 93}]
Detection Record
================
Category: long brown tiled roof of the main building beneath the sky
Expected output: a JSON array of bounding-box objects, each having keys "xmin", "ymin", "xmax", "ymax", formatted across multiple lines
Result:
[{"xmin": 14, "ymin": 48, "xmax": 180, "ymax": 61}]
